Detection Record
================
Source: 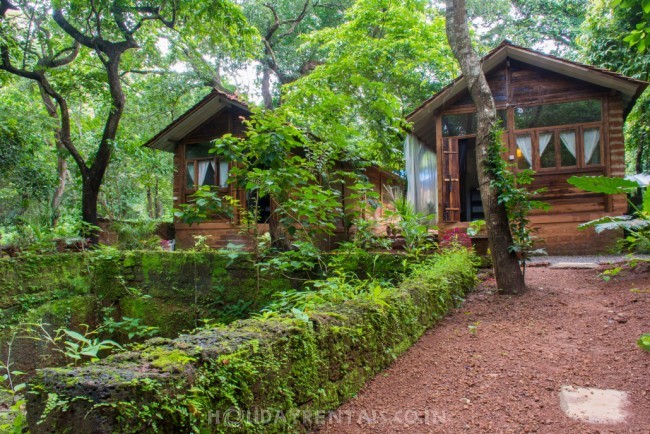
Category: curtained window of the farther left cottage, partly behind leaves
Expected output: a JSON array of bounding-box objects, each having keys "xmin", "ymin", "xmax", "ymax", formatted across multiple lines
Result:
[{"xmin": 185, "ymin": 144, "xmax": 228, "ymax": 190}]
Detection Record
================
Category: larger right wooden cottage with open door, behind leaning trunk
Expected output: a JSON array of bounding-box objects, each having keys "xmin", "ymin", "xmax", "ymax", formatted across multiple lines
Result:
[{"xmin": 405, "ymin": 41, "xmax": 648, "ymax": 254}]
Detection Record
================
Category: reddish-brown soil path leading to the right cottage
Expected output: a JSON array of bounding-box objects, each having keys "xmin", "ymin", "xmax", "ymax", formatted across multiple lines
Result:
[{"xmin": 317, "ymin": 264, "xmax": 650, "ymax": 433}]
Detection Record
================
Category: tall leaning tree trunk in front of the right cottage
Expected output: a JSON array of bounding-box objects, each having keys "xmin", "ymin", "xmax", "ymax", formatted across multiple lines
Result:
[{"xmin": 445, "ymin": 0, "xmax": 526, "ymax": 294}]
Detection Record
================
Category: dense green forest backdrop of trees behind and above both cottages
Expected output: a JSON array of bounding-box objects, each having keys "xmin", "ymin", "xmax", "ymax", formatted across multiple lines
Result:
[{"xmin": 0, "ymin": 0, "xmax": 650, "ymax": 244}]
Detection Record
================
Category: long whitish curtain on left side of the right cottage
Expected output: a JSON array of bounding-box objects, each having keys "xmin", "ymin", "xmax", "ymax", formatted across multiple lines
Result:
[{"xmin": 404, "ymin": 134, "xmax": 438, "ymax": 219}]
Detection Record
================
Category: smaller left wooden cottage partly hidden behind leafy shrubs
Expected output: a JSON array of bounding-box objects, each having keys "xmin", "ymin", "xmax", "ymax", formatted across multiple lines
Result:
[{"xmin": 144, "ymin": 89, "xmax": 403, "ymax": 248}]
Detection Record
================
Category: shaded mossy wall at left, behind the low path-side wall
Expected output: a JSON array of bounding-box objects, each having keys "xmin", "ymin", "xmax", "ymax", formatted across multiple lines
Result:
[{"xmin": 0, "ymin": 251, "xmax": 292, "ymax": 372}]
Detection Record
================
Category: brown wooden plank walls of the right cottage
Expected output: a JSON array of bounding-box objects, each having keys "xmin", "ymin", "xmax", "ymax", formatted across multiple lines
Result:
[{"xmin": 436, "ymin": 61, "xmax": 627, "ymax": 254}]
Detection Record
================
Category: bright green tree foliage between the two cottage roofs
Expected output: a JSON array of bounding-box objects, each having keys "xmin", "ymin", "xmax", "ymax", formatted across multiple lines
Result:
[{"xmin": 282, "ymin": 0, "xmax": 457, "ymax": 168}]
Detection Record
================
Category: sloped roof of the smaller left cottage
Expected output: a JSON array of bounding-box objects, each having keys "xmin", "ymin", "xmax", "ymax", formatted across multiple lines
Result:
[{"xmin": 143, "ymin": 89, "xmax": 250, "ymax": 152}]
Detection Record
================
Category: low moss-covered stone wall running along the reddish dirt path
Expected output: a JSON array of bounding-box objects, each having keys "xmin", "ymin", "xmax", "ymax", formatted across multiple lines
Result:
[{"xmin": 27, "ymin": 252, "xmax": 475, "ymax": 434}]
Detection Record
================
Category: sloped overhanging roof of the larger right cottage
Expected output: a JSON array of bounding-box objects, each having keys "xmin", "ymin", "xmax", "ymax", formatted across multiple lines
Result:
[{"xmin": 406, "ymin": 40, "xmax": 648, "ymax": 141}]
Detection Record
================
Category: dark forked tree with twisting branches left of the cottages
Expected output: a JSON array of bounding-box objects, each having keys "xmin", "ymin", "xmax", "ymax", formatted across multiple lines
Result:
[{"xmin": 0, "ymin": 0, "xmax": 251, "ymax": 241}]
